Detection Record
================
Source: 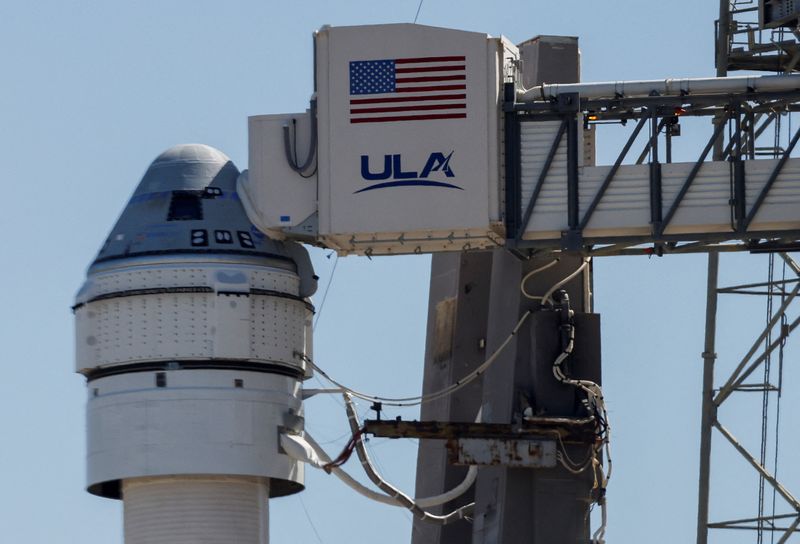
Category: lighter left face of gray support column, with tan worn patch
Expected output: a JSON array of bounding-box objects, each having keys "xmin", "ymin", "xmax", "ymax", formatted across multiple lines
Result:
[{"xmin": 411, "ymin": 251, "xmax": 492, "ymax": 544}]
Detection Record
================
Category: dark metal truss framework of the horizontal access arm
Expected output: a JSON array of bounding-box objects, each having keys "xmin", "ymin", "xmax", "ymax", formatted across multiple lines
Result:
[{"xmin": 505, "ymin": 83, "xmax": 800, "ymax": 255}]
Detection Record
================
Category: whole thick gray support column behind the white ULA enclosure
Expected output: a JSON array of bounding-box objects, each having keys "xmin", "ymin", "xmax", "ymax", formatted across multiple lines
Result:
[{"xmin": 412, "ymin": 36, "xmax": 584, "ymax": 544}]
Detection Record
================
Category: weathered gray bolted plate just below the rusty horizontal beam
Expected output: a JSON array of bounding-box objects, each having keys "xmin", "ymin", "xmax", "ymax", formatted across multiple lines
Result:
[{"xmin": 447, "ymin": 438, "xmax": 556, "ymax": 468}]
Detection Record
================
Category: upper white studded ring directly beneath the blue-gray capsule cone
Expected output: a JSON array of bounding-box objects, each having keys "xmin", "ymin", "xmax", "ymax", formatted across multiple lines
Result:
[{"xmin": 75, "ymin": 263, "xmax": 308, "ymax": 371}]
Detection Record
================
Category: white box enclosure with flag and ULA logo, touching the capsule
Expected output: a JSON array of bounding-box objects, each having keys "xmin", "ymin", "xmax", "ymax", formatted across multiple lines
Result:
[{"xmin": 239, "ymin": 24, "xmax": 518, "ymax": 254}]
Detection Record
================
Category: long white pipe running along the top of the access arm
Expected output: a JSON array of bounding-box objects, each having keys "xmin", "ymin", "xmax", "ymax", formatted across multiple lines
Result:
[{"xmin": 517, "ymin": 75, "xmax": 800, "ymax": 102}]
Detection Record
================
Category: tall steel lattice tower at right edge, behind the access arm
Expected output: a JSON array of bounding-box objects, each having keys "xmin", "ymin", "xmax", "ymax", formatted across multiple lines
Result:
[{"xmin": 697, "ymin": 5, "xmax": 800, "ymax": 544}]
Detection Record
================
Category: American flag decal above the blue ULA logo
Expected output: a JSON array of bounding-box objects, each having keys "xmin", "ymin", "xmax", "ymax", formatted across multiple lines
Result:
[{"xmin": 350, "ymin": 56, "xmax": 467, "ymax": 123}]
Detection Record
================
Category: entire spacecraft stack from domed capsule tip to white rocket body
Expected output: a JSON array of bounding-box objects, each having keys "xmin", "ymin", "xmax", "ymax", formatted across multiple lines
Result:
[{"xmin": 74, "ymin": 145, "xmax": 316, "ymax": 544}]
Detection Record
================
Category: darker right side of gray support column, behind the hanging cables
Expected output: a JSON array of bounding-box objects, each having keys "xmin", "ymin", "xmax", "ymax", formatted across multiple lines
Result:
[{"xmin": 472, "ymin": 252, "xmax": 599, "ymax": 544}]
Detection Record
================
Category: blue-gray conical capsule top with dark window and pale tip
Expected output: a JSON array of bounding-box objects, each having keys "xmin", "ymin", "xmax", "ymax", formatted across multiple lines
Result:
[{"xmin": 90, "ymin": 144, "xmax": 316, "ymax": 282}]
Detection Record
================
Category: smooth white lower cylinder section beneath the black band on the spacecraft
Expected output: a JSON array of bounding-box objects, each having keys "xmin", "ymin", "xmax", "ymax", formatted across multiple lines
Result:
[{"xmin": 87, "ymin": 369, "xmax": 303, "ymax": 486}]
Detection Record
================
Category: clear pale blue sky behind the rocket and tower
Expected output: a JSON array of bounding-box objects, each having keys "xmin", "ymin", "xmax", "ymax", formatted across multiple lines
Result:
[{"xmin": 0, "ymin": 0, "xmax": 800, "ymax": 544}]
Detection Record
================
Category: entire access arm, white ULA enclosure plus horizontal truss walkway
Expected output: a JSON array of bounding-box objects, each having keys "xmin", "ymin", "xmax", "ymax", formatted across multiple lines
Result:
[{"xmin": 238, "ymin": 24, "xmax": 800, "ymax": 255}]
